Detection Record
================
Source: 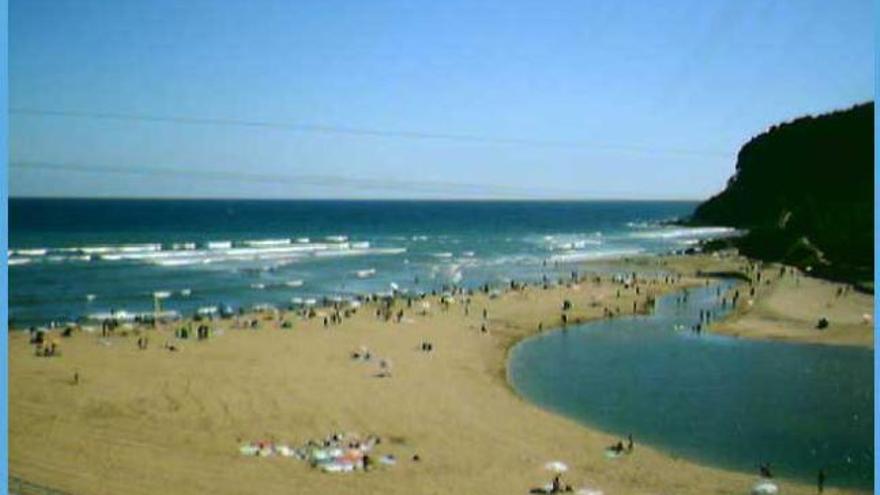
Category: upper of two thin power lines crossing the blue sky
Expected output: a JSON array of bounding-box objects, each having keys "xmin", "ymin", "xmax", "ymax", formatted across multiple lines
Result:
[{"xmin": 9, "ymin": 107, "xmax": 734, "ymax": 158}]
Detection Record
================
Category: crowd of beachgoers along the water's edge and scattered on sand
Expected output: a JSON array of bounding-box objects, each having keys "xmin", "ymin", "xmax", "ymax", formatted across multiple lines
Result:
[{"xmin": 8, "ymin": 254, "xmax": 872, "ymax": 495}]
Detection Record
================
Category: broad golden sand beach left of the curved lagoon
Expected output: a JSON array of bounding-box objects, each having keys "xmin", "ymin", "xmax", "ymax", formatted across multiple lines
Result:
[{"xmin": 9, "ymin": 259, "xmax": 872, "ymax": 494}]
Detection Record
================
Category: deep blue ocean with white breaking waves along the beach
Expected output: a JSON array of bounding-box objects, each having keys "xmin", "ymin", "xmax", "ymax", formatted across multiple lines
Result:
[{"xmin": 8, "ymin": 198, "xmax": 731, "ymax": 328}]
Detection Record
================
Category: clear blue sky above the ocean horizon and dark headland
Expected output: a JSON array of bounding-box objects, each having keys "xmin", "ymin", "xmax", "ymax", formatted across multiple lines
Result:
[{"xmin": 9, "ymin": 0, "xmax": 874, "ymax": 199}]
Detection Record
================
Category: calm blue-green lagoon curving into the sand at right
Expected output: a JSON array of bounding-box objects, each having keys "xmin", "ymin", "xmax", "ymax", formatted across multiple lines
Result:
[{"xmin": 508, "ymin": 282, "xmax": 874, "ymax": 489}]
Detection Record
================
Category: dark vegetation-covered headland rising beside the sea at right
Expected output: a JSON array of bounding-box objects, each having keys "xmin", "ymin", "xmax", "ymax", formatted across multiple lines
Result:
[{"xmin": 690, "ymin": 102, "xmax": 874, "ymax": 281}]
